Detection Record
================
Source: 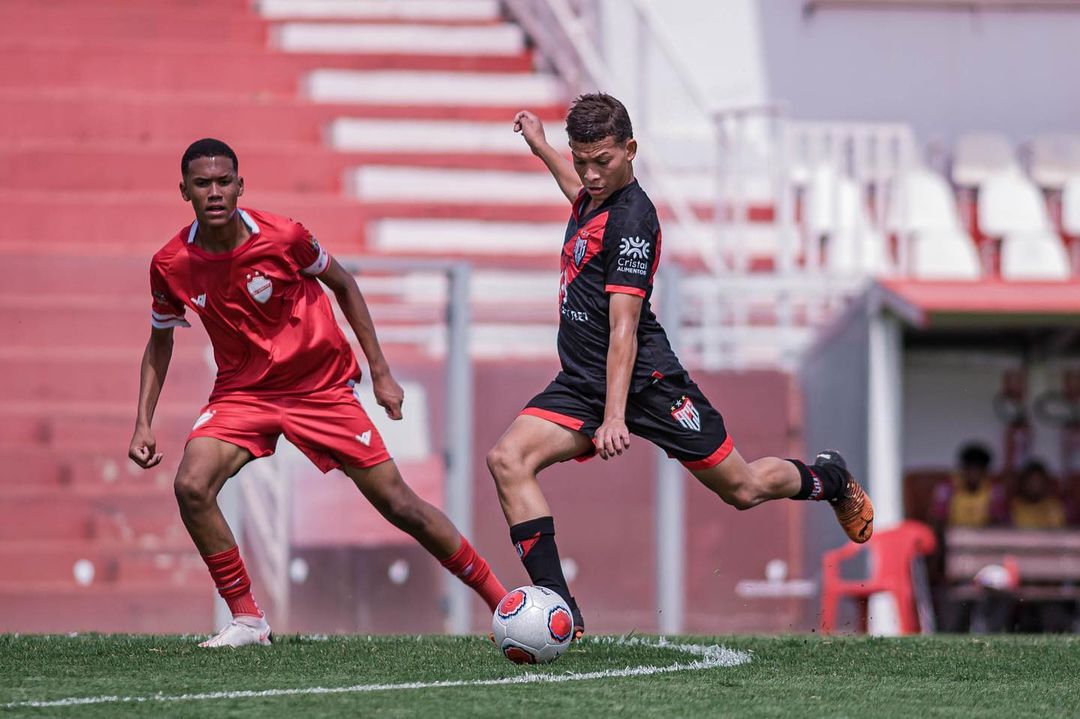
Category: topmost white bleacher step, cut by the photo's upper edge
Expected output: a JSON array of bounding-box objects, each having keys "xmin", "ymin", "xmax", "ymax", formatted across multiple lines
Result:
[{"xmin": 258, "ymin": 0, "xmax": 499, "ymax": 23}]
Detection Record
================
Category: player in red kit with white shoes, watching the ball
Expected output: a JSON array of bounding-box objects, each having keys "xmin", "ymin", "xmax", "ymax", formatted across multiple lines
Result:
[{"xmin": 129, "ymin": 138, "xmax": 505, "ymax": 647}]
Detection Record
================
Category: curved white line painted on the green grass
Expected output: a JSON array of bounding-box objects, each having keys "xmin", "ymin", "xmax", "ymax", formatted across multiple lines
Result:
[{"xmin": 0, "ymin": 637, "xmax": 751, "ymax": 709}]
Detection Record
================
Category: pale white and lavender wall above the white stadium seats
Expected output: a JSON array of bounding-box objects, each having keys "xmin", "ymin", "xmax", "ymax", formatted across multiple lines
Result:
[{"xmin": 613, "ymin": 0, "xmax": 1080, "ymax": 144}]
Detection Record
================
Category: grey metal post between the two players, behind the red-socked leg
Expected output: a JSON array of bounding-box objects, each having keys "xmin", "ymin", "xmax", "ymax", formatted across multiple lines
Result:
[{"xmin": 446, "ymin": 263, "xmax": 473, "ymax": 634}]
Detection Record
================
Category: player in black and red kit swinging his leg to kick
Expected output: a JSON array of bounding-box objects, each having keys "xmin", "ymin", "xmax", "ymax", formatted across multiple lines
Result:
[{"xmin": 487, "ymin": 93, "xmax": 874, "ymax": 637}]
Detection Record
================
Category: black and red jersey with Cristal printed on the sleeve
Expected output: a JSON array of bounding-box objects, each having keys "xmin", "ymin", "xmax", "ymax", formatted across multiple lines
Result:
[{"xmin": 556, "ymin": 180, "xmax": 685, "ymax": 395}]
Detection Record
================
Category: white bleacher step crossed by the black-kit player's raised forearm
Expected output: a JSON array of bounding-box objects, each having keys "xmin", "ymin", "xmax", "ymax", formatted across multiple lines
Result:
[{"xmin": 326, "ymin": 118, "xmax": 568, "ymax": 154}]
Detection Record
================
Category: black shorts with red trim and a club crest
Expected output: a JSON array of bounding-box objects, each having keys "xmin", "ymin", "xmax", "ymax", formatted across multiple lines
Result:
[{"xmin": 522, "ymin": 375, "xmax": 733, "ymax": 470}]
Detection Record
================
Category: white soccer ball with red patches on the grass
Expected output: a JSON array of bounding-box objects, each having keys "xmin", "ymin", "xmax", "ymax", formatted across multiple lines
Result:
[{"xmin": 491, "ymin": 586, "xmax": 573, "ymax": 664}]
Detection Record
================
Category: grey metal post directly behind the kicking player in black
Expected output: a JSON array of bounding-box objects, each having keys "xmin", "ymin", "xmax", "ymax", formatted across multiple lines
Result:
[{"xmin": 656, "ymin": 264, "xmax": 686, "ymax": 635}]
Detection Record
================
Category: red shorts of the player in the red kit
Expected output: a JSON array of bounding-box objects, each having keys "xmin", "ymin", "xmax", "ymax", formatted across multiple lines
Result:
[{"xmin": 187, "ymin": 377, "xmax": 390, "ymax": 472}]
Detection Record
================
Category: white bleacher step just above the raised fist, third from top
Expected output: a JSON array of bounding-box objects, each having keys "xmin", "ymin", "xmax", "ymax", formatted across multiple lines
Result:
[{"xmin": 303, "ymin": 69, "xmax": 562, "ymax": 107}]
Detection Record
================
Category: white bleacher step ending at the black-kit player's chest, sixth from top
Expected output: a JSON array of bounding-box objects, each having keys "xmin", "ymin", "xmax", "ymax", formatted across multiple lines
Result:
[{"xmin": 368, "ymin": 219, "xmax": 566, "ymax": 256}]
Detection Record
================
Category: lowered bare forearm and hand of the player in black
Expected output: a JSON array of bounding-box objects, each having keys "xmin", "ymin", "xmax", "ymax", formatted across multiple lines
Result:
[{"xmin": 594, "ymin": 293, "xmax": 643, "ymax": 460}]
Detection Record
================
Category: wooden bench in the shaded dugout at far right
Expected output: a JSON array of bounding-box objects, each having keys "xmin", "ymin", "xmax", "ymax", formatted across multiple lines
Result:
[{"xmin": 945, "ymin": 528, "xmax": 1080, "ymax": 602}]
